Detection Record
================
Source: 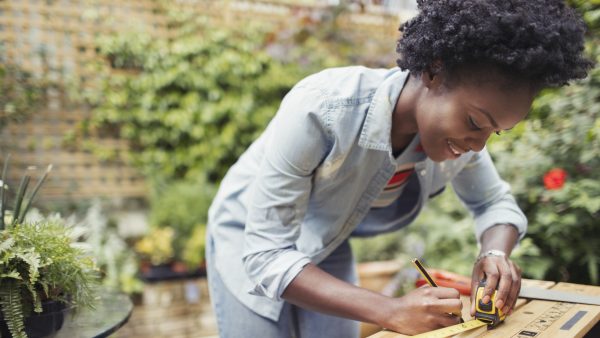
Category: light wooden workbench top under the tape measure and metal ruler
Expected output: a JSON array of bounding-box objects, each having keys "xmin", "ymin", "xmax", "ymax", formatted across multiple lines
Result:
[{"xmin": 368, "ymin": 279, "xmax": 600, "ymax": 338}]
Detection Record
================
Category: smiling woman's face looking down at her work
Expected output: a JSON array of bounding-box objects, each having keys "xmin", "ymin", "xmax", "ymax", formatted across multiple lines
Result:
[{"xmin": 415, "ymin": 75, "xmax": 534, "ymax": 162}]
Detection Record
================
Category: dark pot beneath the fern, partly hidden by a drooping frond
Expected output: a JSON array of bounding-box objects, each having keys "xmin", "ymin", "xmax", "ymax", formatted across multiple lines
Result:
[{"xmin": 0, "ymin": 301, "xmax": 69, "ymax": 338}]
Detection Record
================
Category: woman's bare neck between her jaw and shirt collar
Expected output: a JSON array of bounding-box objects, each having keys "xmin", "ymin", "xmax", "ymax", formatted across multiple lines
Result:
[{"xmin": 392, "ymin": 75, "xmax": 422, "ymax": 153}]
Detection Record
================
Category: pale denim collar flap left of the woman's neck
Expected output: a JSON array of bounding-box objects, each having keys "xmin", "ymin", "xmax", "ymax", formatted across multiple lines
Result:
[{"xmin": 358, "ymin": 67, "xmax": 409, "ymax": 152}]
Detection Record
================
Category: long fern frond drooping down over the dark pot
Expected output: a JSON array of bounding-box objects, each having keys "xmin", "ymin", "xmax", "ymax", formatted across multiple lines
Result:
[{"xmin": 0, "ymin": 279, "xmax": 27, "ymax": 338}]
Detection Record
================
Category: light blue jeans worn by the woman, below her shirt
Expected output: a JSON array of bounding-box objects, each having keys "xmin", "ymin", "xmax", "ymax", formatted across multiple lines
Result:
[{"xmin": 206, "ymin": 235, "xmax": 359, "ymax": 338}]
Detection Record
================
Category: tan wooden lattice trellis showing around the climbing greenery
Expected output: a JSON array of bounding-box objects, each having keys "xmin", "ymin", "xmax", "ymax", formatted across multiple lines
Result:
[{"xmin": 0, "ymin": 0, "xmax": 399, "ymax": 200}]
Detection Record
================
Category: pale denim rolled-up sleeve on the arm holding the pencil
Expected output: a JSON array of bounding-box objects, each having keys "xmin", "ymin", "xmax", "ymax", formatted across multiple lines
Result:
[{"xmin": 243, "ymin": 86, "xmax": 330, "ymax": 300}]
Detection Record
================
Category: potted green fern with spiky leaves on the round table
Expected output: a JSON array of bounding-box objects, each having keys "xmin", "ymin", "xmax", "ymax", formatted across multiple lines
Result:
[{"xmin": 0, "ymin": 158, "xmax": 97, "ymax": 338}]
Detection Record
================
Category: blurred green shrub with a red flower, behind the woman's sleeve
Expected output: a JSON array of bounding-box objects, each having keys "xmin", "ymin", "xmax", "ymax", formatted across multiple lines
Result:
[{"xmin": 356, "ymin": 0, "xmax": 600, "ymax": 284}]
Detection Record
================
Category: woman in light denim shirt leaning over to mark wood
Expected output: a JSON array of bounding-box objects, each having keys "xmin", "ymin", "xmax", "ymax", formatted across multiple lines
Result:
[{"xmin": 207, "ymin": 0, "xmax": 590, "ymax": 338}]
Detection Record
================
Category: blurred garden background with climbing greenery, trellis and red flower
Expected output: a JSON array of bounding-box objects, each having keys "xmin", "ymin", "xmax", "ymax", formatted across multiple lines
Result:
[{"xmin": 0, "ymin": 0, "xmax": 600, "ymax": 337}]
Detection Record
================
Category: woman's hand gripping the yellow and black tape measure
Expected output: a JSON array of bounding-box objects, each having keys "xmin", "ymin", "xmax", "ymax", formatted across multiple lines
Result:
[{"xmin": 471, "ymin": 255, "xmax": 521, "ymax": 316}]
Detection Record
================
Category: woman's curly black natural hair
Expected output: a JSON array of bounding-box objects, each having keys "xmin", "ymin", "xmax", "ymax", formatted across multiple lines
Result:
[{"xmin": 396, "ymin": 0, "xmax": 592, "ymax": 89}]
